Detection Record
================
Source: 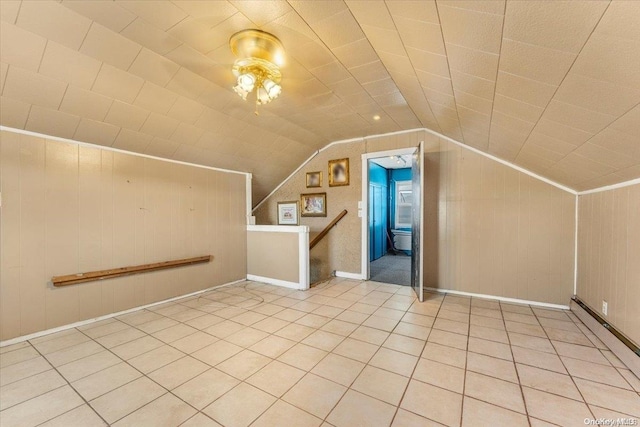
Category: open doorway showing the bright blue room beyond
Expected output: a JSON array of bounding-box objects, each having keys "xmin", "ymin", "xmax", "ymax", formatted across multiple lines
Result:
[{"xmin": 361, "ymin": 148, "xmax": 422, "ymax": 296}]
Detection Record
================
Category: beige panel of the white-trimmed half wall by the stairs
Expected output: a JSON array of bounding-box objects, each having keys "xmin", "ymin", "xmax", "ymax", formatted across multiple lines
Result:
[{"xmin": 247, "ymin": 231, "xmax": 300, "ymax": 283}]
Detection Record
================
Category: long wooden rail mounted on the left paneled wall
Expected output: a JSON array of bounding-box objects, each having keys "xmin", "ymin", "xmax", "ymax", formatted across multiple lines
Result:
[{"xmin": 51, "ymin": 255, "xmax": 213, "ymax": 286}]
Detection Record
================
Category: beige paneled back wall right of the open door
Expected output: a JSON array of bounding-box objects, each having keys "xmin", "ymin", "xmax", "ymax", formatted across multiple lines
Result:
[{"xmin": 425, "ymin": 140, "xmax": 576, "ymax": 305}]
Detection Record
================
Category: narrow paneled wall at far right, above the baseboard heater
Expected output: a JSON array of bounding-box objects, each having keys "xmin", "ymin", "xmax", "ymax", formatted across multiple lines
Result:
[{"xmin": 577, "ymin": 184, "xmax": 640, "ymax": 343}]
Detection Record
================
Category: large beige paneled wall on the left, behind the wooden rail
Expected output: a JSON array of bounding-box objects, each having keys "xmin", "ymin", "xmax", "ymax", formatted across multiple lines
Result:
[{"xmin": 0, "ymin": 131, "xmax": 246, "ymax": 340}]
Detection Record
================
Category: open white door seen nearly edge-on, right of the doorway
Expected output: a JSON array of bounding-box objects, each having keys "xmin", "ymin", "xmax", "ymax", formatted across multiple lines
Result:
[{"xmin": 411, "ymin": 141, "xmax": 424, "ymax": 302}]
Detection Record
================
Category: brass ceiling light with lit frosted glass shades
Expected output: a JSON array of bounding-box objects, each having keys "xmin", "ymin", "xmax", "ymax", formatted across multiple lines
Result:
[{"xmin": 229, "ymin": 30, "xmax": 284, "ymax": 105}]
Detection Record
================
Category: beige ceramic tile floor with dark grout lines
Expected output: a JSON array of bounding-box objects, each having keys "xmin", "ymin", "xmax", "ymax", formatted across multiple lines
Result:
[{"xmin": 0, "ymin": 279, "xmax": 640, "ymax": 427}]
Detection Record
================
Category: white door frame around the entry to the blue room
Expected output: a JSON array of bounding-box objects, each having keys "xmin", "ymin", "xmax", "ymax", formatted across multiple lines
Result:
[{"xmin": 358, "ymin": 146, "xmax": 424, "ymax": 280}]
